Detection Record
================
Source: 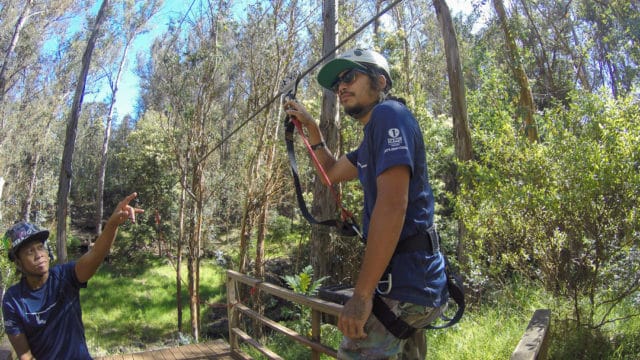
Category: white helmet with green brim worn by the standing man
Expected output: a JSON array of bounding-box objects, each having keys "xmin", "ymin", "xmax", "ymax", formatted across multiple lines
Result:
[{"xmin": 318, "ymin": 49, "xmax": 392, "ymax": 92}]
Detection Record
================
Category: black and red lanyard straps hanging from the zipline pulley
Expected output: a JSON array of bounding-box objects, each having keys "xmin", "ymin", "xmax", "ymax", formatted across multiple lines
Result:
[{"xmin": 282, "ymin": 76, "xmax": 363, "ymax": 239}]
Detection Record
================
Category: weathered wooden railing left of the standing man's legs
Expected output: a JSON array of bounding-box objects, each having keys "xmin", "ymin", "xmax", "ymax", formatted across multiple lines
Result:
[{"xmin": 227, "ymin": 270, "xmax": 342, "ymax": 360}]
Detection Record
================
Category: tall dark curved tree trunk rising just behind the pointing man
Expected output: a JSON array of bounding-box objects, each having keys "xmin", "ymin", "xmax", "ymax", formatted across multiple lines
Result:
[{"xmin": 56, "ymin": 0, "xmax": 109, "ymax": 263}]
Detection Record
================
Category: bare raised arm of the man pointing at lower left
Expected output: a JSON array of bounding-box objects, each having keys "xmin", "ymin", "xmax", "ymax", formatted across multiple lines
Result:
[{"xmin": 75, "ymin": 193, "xmax": 144, "ymax": 283}]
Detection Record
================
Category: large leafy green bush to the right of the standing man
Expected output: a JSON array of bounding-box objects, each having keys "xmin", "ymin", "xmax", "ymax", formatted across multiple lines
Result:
[{"xmin": 457, "ymin": 93, "xmax": 640, "ymax": 326}]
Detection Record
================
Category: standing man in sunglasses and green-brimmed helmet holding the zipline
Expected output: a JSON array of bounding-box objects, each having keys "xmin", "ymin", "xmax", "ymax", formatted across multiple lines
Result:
[{"xmin": 284, "ymin": 49, "xmax": 448, "ymax": 359}]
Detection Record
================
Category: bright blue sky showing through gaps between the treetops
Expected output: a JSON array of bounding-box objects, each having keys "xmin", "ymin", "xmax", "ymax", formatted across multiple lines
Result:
[{"xmin": 107, "ymin": 0, "xmax": 472, "ymax": 121}]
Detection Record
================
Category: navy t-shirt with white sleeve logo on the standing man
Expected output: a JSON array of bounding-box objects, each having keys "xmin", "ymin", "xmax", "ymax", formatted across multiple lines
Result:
[{"xmin": 347, "ymin": 100, "xmax": 448, "ymax": 307}]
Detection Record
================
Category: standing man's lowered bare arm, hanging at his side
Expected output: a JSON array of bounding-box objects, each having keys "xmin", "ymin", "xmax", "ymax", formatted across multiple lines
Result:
[{"xmin": 338, "ymin": 166, "xmax": 410, "ymax": 339}]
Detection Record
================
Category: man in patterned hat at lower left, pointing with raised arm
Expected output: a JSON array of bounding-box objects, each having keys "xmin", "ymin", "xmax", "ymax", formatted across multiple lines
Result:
[{"xmin": 2, "ymin": 193, "xmax": 143, "ymax": 360}]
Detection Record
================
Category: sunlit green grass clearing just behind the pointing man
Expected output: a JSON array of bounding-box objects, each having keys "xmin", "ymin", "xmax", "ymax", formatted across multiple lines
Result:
[{"xmin": 80, "ymin": 257, "xmax": 225, "ymax": 356}]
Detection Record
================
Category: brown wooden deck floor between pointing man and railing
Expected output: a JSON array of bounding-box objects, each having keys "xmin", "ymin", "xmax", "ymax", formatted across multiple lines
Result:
[{"xmin": 96, "ymin": 340, "xmax": 240, "ymax": 360}]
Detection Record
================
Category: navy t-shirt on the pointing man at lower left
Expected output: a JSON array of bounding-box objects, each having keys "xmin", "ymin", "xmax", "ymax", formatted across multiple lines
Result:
[{"xmin": 2, "ymin": 262, "xmax": 91, "ymax": 360}]
